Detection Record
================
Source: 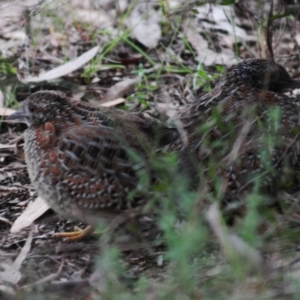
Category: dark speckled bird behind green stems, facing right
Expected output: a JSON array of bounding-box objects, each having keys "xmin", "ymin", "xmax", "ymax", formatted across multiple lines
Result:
[{"xmin": 171, "ymin": 59, "xmax": 300, "ymax": 213}]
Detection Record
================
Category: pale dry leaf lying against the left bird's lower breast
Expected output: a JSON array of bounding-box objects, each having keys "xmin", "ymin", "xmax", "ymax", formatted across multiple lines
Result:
[{"xmin": 10, "ymin": 197, "xmax": 50, "ymax": 233}]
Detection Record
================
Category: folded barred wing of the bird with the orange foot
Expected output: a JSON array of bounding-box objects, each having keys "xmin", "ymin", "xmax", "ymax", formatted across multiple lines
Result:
[{"xmin": 56, "ymin": 125, "xmax": 145, "ymax": 210}]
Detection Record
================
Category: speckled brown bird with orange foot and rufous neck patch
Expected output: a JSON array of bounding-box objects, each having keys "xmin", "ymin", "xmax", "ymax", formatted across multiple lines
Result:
[{"xmin": 9, "ymin": 90, "xmax": 177, "ymax": 241}]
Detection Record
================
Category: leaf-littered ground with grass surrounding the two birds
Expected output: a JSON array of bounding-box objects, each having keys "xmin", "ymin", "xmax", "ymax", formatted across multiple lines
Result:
[{"xmin": 0, "ymin": 0, "xmax": 300, "ymax": 299}]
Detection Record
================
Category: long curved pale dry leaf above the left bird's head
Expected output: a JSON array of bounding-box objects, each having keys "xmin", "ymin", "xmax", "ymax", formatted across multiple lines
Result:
[{"xmin": 19, "ymin": 46, "xmax": 100, "ymax": 83}]
